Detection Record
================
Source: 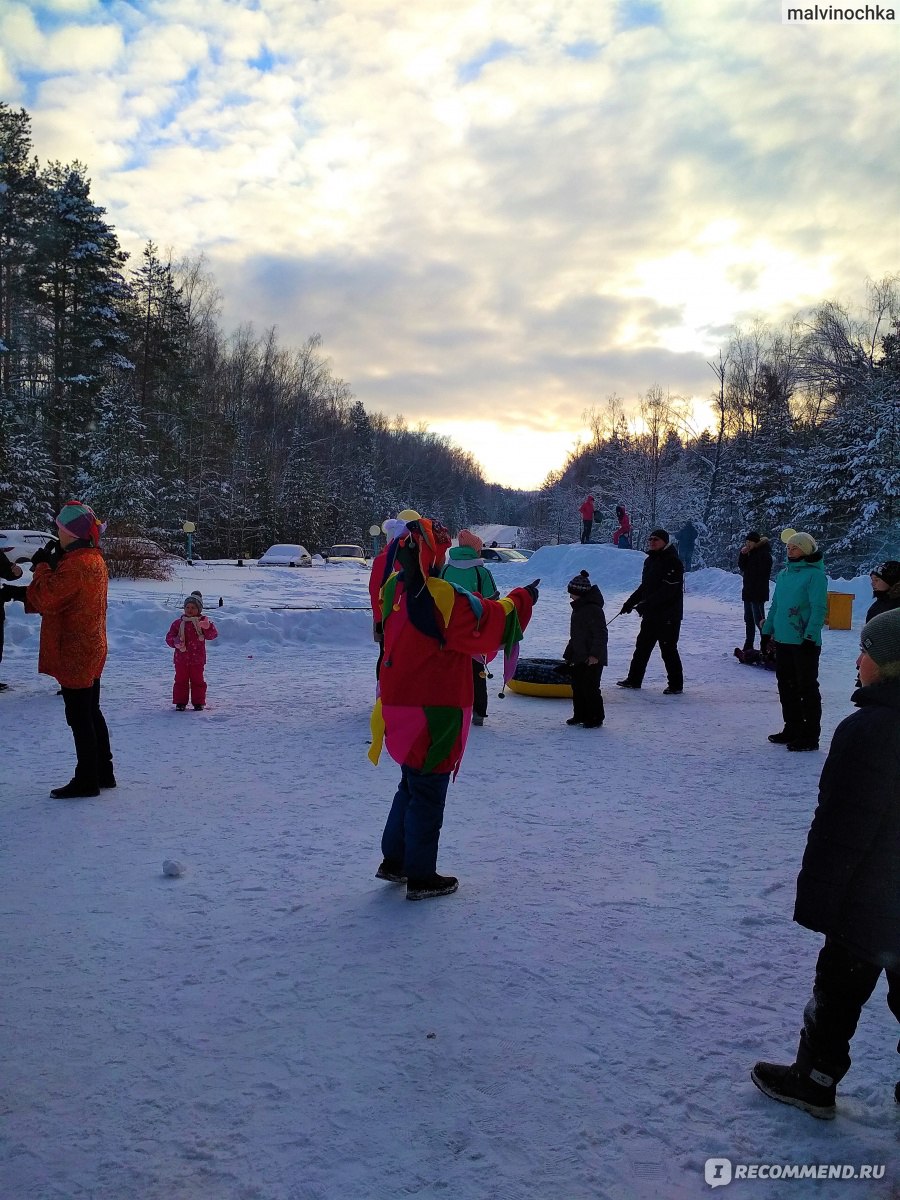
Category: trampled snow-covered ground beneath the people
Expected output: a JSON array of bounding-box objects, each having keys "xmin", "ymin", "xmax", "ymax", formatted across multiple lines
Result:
[{"xmin": 0, "ymin": 546, "xmax": 900, "ymax": 1200}]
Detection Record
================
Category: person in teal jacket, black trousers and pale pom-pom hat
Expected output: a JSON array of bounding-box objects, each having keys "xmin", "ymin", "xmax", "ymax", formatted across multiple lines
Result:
[{"xmin": 762, "ymin": 533, "xmax": 828, "ymax": 750}]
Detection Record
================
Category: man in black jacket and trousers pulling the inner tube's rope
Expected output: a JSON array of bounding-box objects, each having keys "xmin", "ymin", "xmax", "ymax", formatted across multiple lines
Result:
[{"xmin": 616, "ymin": 529, "xmax": 684, "ymax": 696}]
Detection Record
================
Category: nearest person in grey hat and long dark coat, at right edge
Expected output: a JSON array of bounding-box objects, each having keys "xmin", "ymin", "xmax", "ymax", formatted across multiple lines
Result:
[{"xmin": 750, "ymin": 608, "xmax": 900, "ymax": 1120}]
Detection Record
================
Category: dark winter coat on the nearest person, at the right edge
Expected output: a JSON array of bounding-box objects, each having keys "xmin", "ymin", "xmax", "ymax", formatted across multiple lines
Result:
[{"xmin": 793, "ymin": 679, "xmax": 900, "ymax": 971}]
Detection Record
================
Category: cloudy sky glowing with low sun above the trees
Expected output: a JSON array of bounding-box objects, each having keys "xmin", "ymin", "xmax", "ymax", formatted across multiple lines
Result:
[{"xmin": 0, "ymin": 0, "xmax": 900, "ymax": 486}]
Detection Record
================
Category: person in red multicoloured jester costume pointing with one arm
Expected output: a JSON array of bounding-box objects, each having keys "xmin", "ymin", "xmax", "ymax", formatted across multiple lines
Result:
[{"xmin": 368, "ymin": 517, "xmax": 540, "ymax": 900}]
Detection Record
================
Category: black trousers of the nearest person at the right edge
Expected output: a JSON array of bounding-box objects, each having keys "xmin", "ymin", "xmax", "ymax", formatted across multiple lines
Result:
[{"xmin": 797, "ymin": 937, "xmax": 900, "ymax": 1084}]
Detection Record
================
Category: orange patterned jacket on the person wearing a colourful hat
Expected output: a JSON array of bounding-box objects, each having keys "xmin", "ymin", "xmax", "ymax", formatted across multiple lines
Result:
[{"xmin": 25, "ymin": 546, "xmax": 109, "ymax": 688}]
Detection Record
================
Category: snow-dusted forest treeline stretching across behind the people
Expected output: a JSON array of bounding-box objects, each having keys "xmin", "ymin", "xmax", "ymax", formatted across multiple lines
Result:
[{"xmin": 0, "ymin": 103, "xmax": 900, "ymax": 572}]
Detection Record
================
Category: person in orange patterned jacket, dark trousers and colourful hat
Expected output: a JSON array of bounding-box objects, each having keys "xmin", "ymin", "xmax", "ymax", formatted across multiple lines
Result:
[{"xmin": 25, "ymin": 500, "xmax": 115, "ymax": 799}]
